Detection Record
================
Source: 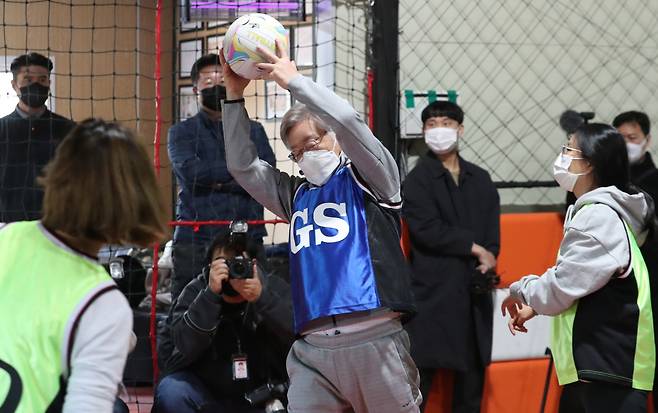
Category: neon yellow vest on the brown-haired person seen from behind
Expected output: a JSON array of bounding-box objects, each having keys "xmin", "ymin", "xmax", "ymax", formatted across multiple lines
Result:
[{"xmin": 0, "ymin": 221, "xmax": 114, "ymax": 413}]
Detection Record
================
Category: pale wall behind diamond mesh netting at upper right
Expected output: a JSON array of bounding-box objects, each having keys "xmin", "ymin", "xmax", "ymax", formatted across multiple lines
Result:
[{"xmin": 399, "ymin": 0, "xmax": 658, "ymax": 205}]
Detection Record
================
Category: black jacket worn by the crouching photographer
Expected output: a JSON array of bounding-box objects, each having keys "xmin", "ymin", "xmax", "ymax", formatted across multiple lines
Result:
[{"xmin": 158, "ymin": 271, "xmax": 294, "ymax": 399}]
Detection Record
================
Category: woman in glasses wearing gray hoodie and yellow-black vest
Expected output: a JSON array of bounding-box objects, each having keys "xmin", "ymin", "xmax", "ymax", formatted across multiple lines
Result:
[{"xmin": 502, "ymin": 124, "xmax": 655, "ymax": 413}]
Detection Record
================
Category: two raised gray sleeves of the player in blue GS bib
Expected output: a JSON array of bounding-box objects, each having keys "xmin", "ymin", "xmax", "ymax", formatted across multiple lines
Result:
[{"xmin": 222, "ymin": 75, "xmax": 401, "ymax": 220}]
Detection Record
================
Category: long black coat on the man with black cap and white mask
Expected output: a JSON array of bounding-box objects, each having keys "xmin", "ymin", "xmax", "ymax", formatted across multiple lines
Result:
[{"xmin": 403, "ymin": 153, "xmax": 500, "ymax": 370}]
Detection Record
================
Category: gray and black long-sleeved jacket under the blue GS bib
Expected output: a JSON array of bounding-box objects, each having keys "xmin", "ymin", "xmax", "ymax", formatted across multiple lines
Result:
[{"xmin": 223, "ymin": 75, "xmax": 415, "ymax": 327}]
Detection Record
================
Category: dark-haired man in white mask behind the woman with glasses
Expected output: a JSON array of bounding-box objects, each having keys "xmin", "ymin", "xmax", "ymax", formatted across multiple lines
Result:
[{"xmin": 612, "ymin": 111, "xmax": 658, "ymax": 209}]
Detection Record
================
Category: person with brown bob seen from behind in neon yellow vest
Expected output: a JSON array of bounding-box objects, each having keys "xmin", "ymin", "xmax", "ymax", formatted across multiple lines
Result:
[{"xmin": 0, "ymin": 119, "xmax": 167, "ymax": 413}]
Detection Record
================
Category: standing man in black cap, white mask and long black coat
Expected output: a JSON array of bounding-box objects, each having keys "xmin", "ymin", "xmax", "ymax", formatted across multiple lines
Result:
[{"xmin": 402, "ymin": 101, "xmax": 500, "ymax": 413}]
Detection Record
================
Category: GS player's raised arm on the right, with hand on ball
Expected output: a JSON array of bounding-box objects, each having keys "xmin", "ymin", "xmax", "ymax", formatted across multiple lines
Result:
[{"xmin": 258, "ymin": 41, "xmax": 401, "ymax": 203}]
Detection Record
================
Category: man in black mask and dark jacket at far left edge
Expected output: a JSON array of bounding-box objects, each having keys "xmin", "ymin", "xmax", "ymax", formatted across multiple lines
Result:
[{"xmin": 0, "ymin": 53, "xmax": 74, "ymax": 222}]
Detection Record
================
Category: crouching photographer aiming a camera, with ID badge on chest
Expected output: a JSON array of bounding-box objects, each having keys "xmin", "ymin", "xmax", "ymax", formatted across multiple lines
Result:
[{"xmin": 154, "ymin": 222, "xmax": 294, "ymax": 413}]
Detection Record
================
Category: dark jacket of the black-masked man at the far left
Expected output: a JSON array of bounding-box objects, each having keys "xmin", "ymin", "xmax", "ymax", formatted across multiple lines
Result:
[{"xmin": 0, "ymin": 110, "xmax": 75, "ymax": 222}]
